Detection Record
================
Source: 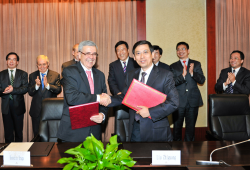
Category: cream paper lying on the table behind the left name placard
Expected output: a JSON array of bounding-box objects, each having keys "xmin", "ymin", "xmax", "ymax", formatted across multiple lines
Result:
[{"xmin": 0, "ymin": 142, "xmax": 34, "ymax": 156}]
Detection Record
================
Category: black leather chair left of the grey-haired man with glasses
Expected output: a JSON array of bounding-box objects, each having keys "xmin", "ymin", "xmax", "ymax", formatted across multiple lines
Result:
[{"xmin": 31, "ymin": 97, "xmax": 63, "ymax": 142}]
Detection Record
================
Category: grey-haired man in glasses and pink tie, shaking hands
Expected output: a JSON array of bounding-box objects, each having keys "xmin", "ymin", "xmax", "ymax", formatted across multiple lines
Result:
[{"xmin": 57, "ymin": 41, "xmax": 110, "ymax": 142}]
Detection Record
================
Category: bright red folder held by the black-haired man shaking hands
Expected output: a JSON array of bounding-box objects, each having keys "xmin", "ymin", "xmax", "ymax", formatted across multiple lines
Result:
[{"xmin": 122, "ymin": 79, "xmax": 167, "ymax": 111}]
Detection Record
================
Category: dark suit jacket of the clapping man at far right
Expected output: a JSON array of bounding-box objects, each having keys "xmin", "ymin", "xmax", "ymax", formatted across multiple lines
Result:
[{"xmin": 215, "ymin": 67, "xmax": 250, "ymax": 95}]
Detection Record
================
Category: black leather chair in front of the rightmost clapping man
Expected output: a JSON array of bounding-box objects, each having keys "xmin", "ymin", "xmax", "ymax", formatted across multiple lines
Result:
[{"xmin": 207, "ymin": 94, "xmax": 250, "ymax": 140}]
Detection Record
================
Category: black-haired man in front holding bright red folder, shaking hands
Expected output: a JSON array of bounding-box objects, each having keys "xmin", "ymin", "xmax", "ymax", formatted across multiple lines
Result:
[{"xmin": 105, "ymin": 41, "xmax": 179, "ymax": 142}]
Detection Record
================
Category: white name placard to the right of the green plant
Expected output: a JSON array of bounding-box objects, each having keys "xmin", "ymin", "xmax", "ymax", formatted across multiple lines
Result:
[{"xmin": 152, "ymin": 150, "xmax": 181, "ymax": 165}]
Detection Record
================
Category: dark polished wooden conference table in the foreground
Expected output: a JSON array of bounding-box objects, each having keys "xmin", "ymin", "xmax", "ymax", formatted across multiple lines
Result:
[{"xmin": 0, "ymin": 141, "xmax": 250, "ymax": 170}]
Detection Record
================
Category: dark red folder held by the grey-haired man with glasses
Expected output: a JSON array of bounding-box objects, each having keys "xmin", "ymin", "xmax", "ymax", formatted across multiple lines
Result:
[{"xmin": 69, "ymin": 102, "xmax": 99, "ymax": 130}]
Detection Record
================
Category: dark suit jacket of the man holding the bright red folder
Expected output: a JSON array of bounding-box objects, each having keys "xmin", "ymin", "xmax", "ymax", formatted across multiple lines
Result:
[{"xmin": 109, "ymin": 65, "xmax": 179, "ymax": 142}]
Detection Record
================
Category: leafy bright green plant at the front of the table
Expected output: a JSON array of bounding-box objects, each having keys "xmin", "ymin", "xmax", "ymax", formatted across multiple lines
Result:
[{"xmin": 57, "ymin": 134, "xmax": 136, "ymax": 170}]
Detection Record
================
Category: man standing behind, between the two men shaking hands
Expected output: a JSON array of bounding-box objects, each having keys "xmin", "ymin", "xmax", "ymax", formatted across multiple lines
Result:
[{"xmin": 108, "ymin": 41, "xmax": 139, "ymax": 95}]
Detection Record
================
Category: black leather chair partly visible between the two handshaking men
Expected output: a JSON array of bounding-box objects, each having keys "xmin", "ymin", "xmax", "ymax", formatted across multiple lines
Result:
[{"xmin": 113, "ymin": 105, "xmax": 129, "ymax": 142}]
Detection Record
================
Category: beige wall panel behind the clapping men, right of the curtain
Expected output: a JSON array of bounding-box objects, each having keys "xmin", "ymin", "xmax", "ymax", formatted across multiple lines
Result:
[{"xmin": 146, "ymin": 0, "xmax": 207, "ymax": 127}]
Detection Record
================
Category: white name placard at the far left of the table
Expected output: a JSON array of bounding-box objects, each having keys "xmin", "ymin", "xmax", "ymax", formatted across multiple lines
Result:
[{"xmin": 3, "ymin": 151, "xmax": 30, "ymax": 166}]
